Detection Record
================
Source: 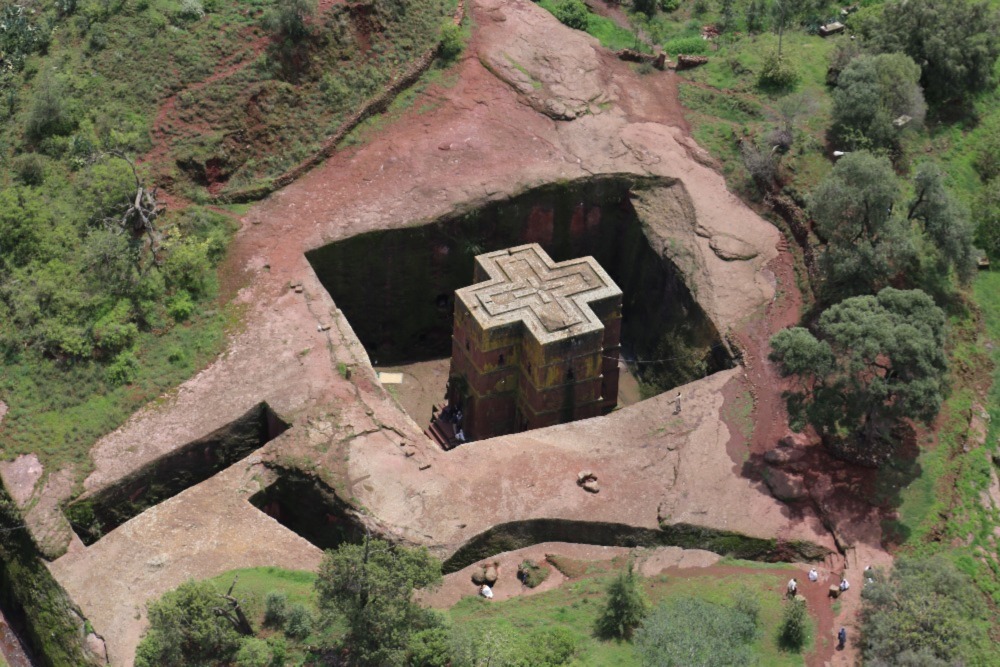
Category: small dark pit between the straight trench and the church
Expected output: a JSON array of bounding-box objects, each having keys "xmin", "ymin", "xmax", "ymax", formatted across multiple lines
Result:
[{"xmin": 250, "ymin": 474, "xmax": 365, "ymax": 549}]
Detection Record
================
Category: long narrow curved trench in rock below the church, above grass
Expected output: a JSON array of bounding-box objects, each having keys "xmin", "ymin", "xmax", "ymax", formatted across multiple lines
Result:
[{"xmin": 442, "ymin": 519, "xmax": 830, "ymax": 574}]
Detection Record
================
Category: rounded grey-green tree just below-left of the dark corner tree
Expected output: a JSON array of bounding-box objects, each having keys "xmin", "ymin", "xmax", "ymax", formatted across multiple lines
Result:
[{"xmin": 832, "ymin": 53, "xmax": 927, "ymax": 149}]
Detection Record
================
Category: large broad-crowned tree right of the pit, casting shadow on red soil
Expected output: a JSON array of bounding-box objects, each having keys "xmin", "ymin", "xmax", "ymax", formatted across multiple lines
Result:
[{"xmin": 771, "ymin": 287, "xmax": 947, "ymax": 463}]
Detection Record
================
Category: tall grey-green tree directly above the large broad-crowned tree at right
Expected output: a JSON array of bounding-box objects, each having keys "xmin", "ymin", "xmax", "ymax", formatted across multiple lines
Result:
[{"xmin": 809, "ymin": 152, "xmax": 913, "ymax": 300}]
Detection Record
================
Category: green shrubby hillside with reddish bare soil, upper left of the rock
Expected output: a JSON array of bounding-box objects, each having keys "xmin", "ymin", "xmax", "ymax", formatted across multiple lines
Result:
[{"xmin": 0, "ymin": 0, "xmax": 462, "ymax": 476}]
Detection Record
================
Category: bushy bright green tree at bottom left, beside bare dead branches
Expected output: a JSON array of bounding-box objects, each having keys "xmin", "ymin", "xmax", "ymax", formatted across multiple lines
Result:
[{"xmin": 135, "ymin": 581, "xmax": 240, "ymax": 667}]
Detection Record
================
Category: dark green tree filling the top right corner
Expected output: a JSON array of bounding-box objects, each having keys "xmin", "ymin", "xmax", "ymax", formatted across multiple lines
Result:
[{"xmin": 858, "ymin": 0, "xmax": 1000, "ymax": 107}]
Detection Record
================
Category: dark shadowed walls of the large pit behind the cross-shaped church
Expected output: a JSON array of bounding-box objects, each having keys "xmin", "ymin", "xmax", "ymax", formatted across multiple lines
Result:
[{"xmin": 307, "ymin": 175, "xmax": 732, "ymax": 408}]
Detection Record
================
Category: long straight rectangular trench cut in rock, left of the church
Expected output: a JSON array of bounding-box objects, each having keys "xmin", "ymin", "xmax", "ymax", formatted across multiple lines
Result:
[{"xmin": 64, "ymin": 403, "xmax": 289, "ymax": 546}]
